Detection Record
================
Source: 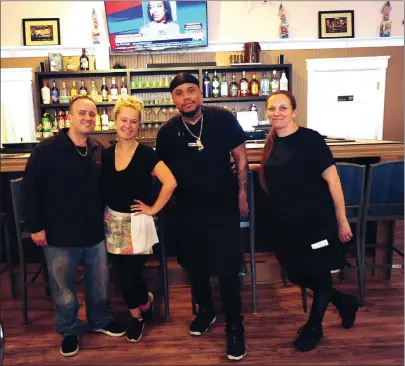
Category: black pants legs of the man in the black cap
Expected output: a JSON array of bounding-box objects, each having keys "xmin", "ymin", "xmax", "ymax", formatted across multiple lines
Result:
[{"xmin": 189, "ymin": 272, "xmax": 242, "ymax": 324}]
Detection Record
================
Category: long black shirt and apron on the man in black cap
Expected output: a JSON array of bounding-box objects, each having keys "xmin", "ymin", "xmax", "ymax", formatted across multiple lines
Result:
[{"xmin": 156, "ymin": 107, "xmax": 245, "ymax": 275}]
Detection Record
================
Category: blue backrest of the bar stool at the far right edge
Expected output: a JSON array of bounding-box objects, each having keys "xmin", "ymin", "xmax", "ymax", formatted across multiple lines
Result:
[{"xmin": 364, "ymin": 160, "xmax": 404, "ymax": 220}]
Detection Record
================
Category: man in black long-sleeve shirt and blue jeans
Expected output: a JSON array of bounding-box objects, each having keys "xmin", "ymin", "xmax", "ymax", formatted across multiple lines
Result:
[{"xmin": 22, "ymin": 97, "xmax": 125, "ymax": 356}]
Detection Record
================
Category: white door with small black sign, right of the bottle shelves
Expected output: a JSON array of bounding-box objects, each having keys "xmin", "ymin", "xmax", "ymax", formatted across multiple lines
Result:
[{"xmin": 306, "ymin": 56, "xmax": 389, "ymax": 140}]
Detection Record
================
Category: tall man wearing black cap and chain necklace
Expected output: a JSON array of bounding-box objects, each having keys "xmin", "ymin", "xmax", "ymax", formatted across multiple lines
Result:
[{"xmin": 156, "ymin": 73, "xmax": 248, "ymax": 360}]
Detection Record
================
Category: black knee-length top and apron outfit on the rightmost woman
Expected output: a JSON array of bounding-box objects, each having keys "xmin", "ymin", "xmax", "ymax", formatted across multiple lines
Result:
[{"xmin": 265, "ymin": 127, "xmax": 345, "ymax": 272}]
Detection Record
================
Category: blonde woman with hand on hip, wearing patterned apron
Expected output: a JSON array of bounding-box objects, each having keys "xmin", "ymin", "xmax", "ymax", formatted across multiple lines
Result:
[{"xmin": 102, "ymin": 97, "xmax": 176, "ymax": 342}]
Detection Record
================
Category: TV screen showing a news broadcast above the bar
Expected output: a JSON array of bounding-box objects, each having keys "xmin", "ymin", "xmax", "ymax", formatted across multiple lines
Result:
[{"xmin": 105, "ymin": 1, "xmax": 208, "ymax": 52}]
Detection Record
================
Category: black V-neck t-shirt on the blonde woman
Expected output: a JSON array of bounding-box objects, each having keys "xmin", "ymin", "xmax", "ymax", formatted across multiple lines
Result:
[{"xmin": 101, "ymin": 144, "xmax": 160, "ymax": 212}]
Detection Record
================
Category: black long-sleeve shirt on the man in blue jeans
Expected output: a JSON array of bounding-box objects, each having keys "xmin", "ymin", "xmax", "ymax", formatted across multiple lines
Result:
[{"xmin": 21, "ymin": 129, "xmax": 104, "ymax": 247}]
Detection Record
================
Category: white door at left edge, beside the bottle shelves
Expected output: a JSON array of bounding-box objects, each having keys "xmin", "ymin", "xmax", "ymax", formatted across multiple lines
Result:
[{"xmin": 0, "ymin": 68, "xmax": 36, "ymax": 144}]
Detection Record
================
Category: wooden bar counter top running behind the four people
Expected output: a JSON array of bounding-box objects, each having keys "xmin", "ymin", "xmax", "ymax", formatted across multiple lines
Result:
[{"xmin": 0, "ymin": 140, "xmax": 404, "ymax": 173}]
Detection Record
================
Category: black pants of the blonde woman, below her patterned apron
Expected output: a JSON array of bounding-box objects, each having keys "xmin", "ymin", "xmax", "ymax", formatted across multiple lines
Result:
[{"xmin": 110, "ymin": 254, "xmax": 148, "ymax": 309}]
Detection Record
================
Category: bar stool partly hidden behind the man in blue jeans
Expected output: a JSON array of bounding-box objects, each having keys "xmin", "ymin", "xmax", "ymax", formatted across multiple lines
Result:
[{"xmin": 10, "ymin": 178, "xmax": 50, "ymax": 325}]
